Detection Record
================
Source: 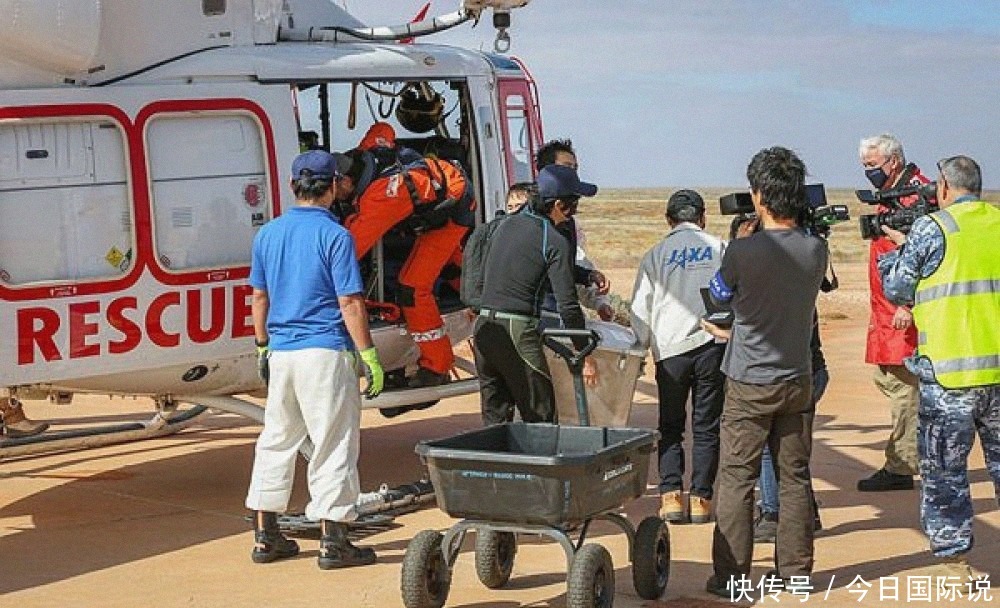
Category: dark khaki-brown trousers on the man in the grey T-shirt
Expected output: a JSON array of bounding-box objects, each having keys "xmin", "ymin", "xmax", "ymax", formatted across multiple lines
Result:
[{"xmin": 712, "ymin": 376, "xmax": 815, "ymax": 581}]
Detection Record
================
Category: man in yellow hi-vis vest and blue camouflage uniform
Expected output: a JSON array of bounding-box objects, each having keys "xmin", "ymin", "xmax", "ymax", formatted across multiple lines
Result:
[{"xmin": 878, "ymin": 156, "xmax": 1000, "ymax": 578}]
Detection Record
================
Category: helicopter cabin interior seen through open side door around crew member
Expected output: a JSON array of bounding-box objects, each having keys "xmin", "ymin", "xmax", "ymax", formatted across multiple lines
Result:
[{"xmin": 295, "ymin": 80, "xmax": 482, "ymax": 326}]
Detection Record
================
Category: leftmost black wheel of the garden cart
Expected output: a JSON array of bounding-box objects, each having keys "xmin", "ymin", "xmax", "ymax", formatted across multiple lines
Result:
[{"xmin": 400, "ymin": 530, "xmax": 451, "ymax": 608}]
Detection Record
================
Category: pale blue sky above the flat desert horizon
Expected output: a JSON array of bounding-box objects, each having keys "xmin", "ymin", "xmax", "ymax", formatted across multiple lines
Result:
[{"xmin": 336, "ymin": 0, "xmax": 1000, "ymax": 188}]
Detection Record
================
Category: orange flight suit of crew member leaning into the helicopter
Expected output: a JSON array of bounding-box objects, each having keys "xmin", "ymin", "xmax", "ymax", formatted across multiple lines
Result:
[{"xmin": 345, "ymin": 158, "xmax": 469, "ymax": 374}]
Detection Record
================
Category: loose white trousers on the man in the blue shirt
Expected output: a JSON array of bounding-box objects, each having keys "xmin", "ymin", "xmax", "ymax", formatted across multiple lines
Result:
[{"xmin": 246, "ymin": 348, "xmax": 361, "ymax": 521}]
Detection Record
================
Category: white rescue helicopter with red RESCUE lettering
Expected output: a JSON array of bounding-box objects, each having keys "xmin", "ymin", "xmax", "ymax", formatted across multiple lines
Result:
[{"xmin": 0, "ymin": 0, "xmax": 640, "ymax": 457}]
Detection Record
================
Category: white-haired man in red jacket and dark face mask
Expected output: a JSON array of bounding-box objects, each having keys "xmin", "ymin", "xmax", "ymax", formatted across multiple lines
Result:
[{"xmin": 858, "ymin": 133, "xmax": 930, "ymax": 492}]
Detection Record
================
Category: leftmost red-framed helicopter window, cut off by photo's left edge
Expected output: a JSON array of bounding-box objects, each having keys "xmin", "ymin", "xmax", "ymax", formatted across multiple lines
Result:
[{"xmin": 0, "ymin": 119, "xmax": 135, "ymax": 285}]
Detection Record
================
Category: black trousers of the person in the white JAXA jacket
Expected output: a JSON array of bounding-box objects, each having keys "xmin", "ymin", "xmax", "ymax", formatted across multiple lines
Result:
[{"xmin": 656, "ymin": 342, "xmax": 725, "ymax": 499}]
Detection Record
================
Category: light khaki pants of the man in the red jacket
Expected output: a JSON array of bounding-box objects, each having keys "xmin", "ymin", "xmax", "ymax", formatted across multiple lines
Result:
[{"xmin": 875, "ymin": 365, "xmax": 920, "ymax": 475}]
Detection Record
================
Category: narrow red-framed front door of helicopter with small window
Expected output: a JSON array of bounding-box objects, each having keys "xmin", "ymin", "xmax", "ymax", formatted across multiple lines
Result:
[{"xmin": 497, "ymin": 78, "xmax": 542, "ymax": 184}]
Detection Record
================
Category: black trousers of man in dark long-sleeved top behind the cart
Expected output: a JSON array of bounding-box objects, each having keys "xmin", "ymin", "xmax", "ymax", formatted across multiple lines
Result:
[{"xmin": 473, "ymin": 317, "xmax": 557, "ymax": 425}]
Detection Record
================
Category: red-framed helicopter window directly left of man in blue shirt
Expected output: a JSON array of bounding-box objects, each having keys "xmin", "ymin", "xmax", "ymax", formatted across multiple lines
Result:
[{"xmin": 146, "ymin": 112, "xmax": 271, "ymax": 271}]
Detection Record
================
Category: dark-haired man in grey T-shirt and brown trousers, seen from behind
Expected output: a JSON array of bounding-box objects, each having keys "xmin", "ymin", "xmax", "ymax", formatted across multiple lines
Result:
[{"xmin": 706, "ymin": 147, "xmax": 829, "ymax": 598}]
